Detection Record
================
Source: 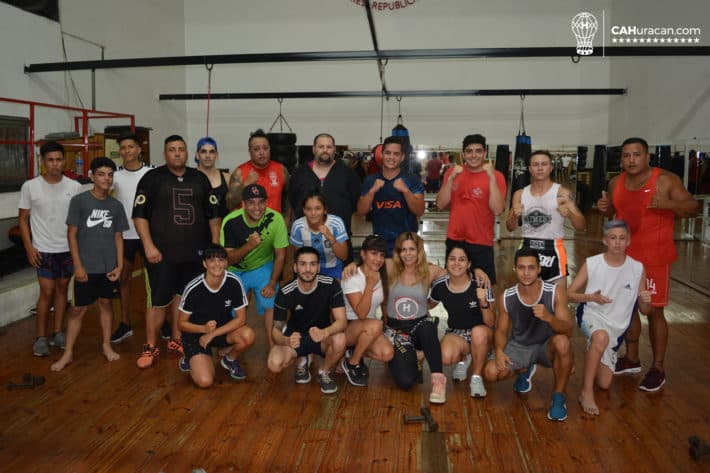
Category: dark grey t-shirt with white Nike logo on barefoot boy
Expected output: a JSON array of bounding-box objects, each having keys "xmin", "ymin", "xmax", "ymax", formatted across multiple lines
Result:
[{"xmin": 66, "ymin": 191, "xmax": 128, "ymax": 274}]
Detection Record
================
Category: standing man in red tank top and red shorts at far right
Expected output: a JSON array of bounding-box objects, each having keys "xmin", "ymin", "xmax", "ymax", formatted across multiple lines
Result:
[{"xmin": 597, "ymin": 138, "xmax": 698, "ymax": 391}]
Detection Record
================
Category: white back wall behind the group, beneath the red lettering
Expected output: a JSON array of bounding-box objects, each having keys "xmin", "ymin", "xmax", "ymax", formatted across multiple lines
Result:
[{"xmin": 186, "ymin": 0, "xmax": 612, "ymax": 168}]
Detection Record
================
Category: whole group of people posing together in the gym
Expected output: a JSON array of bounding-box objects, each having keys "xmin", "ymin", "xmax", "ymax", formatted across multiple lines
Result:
[{"xmin": 19, "ymin": 130, "xmax": 697, "ymax": 420}]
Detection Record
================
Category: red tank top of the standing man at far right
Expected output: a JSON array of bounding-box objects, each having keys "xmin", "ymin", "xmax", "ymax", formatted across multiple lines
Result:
[{"xmin": 612, "ymin": 168, "xmax": 678, "ymax": 266}]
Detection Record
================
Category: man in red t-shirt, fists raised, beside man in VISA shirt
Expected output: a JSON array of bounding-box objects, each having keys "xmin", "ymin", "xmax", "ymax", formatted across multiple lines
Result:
[{"xmin": 436, "ymin": 134, "xmax": 506, "ymax": 284}]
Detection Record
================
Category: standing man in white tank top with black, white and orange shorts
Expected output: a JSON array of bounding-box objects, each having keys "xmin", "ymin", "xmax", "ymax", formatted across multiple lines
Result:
[{"xmin": 505, "ymin": 150, "xmax": 586, "ymax": 287}]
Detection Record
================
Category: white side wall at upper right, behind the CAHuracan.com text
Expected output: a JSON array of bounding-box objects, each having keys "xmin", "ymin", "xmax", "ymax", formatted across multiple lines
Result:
[{"xmin": 609, "ymin": 0, "xmax": 710, "ymax": 144}]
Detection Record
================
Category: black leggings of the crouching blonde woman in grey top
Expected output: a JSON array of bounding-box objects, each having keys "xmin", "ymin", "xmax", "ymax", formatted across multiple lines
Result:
[{"xmin": 389, "ymin": 317, "xmax": 443, "ymax": 389}]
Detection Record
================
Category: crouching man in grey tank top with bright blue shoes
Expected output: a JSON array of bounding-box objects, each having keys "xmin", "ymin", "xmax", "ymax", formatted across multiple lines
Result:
[{"xmin": 484, "ymin": 248, "xmax": 573, "ymax": 421}]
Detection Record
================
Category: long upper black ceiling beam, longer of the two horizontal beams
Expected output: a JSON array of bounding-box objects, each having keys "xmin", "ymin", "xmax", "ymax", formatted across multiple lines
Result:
[{"xmin": 24, "ymin": 46, "xmax": 710, "ymax": 74}]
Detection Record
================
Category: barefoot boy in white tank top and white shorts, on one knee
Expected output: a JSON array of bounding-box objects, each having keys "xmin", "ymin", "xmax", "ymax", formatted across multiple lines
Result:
[{"xmin": 568, "ymin": 220, "xmax": 651, "ymax": 415}]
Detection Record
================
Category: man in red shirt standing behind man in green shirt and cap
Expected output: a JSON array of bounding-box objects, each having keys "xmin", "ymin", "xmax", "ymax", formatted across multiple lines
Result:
[{"xmin": 227, "ymin": 129, "xmax": 289, "ymax": 218}]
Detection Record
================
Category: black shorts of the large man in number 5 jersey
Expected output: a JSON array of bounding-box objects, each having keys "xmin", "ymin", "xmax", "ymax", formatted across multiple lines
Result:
[{"xmin": 145, "ymin": 261, "xmax": 204, "ymax": 308}]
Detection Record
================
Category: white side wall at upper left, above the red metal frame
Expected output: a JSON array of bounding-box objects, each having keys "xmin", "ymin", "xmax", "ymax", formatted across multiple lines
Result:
[{"xmin": 0, "ymin": 0, "xmax": 187, "ymax": 225}]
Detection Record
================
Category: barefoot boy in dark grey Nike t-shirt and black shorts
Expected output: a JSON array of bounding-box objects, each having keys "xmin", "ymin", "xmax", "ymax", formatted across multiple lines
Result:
[{"xmin": 51, "ymin": 157, "xmax": 128, "ymax": 371}]
